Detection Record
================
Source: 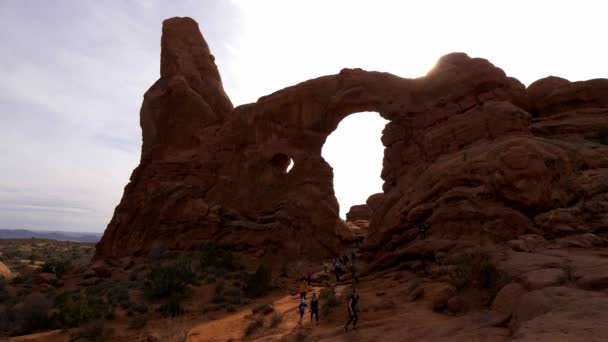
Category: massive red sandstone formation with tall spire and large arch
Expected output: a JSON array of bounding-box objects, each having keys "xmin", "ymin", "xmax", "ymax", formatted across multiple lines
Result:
[{"xmin": 96, "ymin": 18, "xmax": 608, "ymax": 264}]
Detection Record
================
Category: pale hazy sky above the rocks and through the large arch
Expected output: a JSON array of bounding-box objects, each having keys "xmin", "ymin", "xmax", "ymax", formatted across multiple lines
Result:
[{"xmin": 0, "ymin": 0, "xmax": 608, "ymax": 232}]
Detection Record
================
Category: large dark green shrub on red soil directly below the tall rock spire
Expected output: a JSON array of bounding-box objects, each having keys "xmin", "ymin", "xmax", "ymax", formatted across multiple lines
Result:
[{"xmin": 144, "ymin": 259, "xmax": 195, "ymax": 299}]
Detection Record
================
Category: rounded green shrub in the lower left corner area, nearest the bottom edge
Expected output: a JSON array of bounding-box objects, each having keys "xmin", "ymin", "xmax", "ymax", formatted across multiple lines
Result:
[{"xmin": 51, "ymin": 290, "xmax": 111, "ymax": 328}]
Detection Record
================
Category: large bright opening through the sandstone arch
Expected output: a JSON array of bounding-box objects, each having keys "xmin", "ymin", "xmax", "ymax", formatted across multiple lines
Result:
[{"xmin": 321, "ymin": 112, "xmax": 389, "ymax": 219}]
